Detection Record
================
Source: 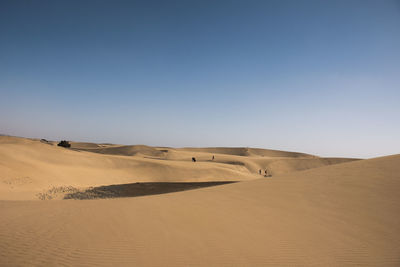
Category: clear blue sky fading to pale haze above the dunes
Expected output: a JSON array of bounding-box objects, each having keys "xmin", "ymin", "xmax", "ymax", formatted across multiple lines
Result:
[{"xmin": 0, "ymin": 0, "xmax": 400, "ymax": 157}]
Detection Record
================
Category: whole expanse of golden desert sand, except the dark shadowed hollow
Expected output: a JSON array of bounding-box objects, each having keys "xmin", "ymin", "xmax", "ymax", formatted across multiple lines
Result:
[{"xmin": 0, "ymin": 136, "xmax": 400, "ymax": 266}]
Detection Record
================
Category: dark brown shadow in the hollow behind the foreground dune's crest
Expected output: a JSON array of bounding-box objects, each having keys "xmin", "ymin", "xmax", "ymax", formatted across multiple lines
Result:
[{"xmin": 64, "ymin": 181, "xmax": 235, "ymax": 199}]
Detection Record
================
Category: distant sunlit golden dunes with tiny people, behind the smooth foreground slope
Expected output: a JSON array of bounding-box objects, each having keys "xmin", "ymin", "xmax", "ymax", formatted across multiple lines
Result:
[{"xmin": 0, "ymin": 136, "xmax": 353, "ymax": 200}]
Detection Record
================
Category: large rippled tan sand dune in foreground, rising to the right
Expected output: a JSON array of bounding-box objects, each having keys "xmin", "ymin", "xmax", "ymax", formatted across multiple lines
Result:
[{"xmin": 0, "ymin": 144, "xmax": 400, "ymax": 266}]
